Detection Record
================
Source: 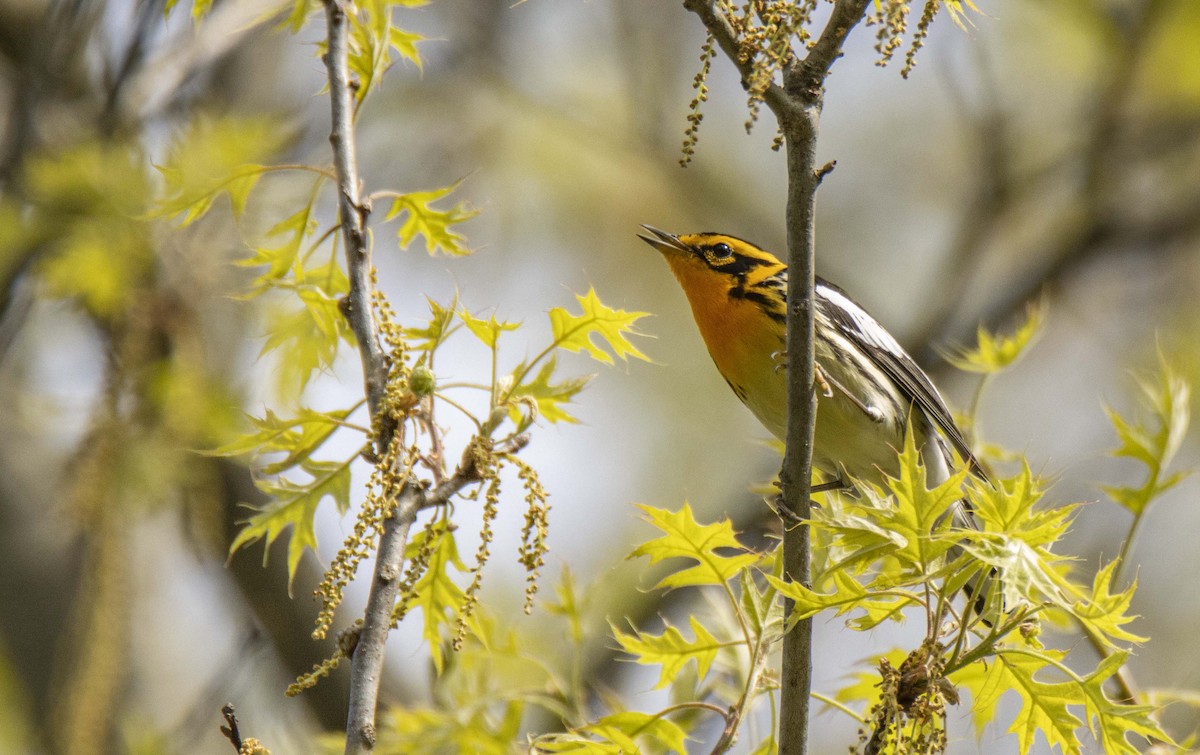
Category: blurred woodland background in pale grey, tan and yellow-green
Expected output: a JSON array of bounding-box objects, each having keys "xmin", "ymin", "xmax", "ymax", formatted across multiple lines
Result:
[{"xmin": 0, "ymin": 0, "xmax": 1200, "ymax": 754}]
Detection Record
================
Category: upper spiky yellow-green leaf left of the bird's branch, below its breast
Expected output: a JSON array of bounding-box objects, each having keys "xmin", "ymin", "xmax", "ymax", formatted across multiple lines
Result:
[{"xmin": 630, "ymin": 503, "xmax": 758, "ymax": 589}]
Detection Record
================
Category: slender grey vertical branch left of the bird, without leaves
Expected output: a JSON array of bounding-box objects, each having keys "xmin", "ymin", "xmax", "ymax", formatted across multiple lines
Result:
[{"xmin": 325, "ymin": 0, "xmax": 425, "ymax": 754}]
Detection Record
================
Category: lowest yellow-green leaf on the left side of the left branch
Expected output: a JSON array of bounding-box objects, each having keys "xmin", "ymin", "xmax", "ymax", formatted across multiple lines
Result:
[{"xmin": 229, "ymin": 460, "xmax": 350, "ymax": 592}]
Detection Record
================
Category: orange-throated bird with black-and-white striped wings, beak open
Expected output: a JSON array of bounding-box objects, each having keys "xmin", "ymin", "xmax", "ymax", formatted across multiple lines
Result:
[{"xmin": 638, "ymin": 226, "xmax": 988, "ymax": 526}]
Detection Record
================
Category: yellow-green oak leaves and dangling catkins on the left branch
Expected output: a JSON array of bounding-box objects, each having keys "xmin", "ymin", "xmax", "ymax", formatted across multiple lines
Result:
[{"xmin": 148, "ymin": 0, "xmax": 646, "ymax": 691}]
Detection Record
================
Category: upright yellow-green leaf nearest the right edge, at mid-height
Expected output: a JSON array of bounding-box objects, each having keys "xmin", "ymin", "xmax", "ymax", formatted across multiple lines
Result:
[{"xmin": 1104, "ymin": 353, "xmax": 1192, "ymax": 516}]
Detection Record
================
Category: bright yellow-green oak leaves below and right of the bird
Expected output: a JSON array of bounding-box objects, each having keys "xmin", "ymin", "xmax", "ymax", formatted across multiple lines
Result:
[{"xmin": 535, "ymin": 311, "xmax": 1188, "ymax": 753}]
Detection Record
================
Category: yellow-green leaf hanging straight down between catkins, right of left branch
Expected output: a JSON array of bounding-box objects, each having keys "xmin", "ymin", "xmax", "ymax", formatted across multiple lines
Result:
[{"xmin": 404, "ymin": 521, "xmax": 467, "ymax": 675}]
